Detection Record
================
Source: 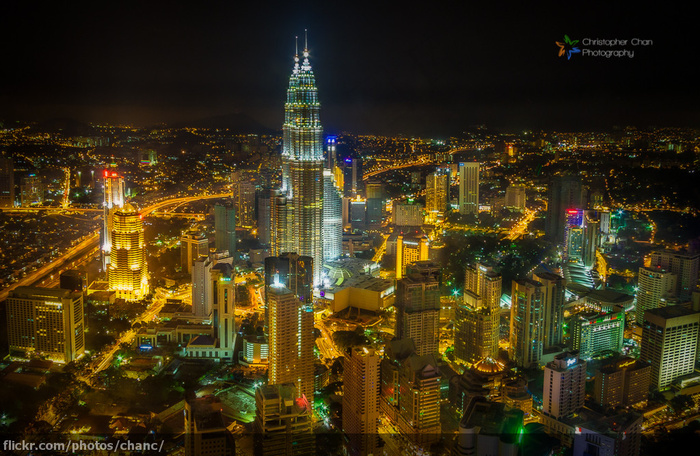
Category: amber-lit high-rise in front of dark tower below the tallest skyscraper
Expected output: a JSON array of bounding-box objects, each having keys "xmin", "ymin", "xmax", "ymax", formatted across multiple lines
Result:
[{"xmin": 266, "ymin": 284, "xmax": 314, "ymax": 404}]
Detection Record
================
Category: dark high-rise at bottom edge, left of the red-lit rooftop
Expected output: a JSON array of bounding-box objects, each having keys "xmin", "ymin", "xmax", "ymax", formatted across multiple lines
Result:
[{"xmin": 185, "ymin": 396, "xmax": 235, "ymax": 456}]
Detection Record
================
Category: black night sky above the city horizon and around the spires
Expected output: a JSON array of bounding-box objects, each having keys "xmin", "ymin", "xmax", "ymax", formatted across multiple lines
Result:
[{"xmin": 0, "ymin": 0, "xmax": 700, "ymax": 135}]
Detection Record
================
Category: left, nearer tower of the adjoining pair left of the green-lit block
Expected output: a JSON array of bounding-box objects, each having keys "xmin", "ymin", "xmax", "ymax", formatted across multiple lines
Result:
[{"xmin": 510, "ymin": 279, "xmax": 545, "ymax": 367}]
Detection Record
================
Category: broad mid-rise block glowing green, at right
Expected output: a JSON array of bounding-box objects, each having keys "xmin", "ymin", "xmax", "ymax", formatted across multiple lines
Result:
[{"xmin": 569, "ymin": 306, "xmax": 625, "ymax": 359}]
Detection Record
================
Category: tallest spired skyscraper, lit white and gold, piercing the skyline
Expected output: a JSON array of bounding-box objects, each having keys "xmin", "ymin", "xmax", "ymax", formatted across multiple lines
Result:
[{"xmin": 282, "ymin": 33, "xmax": 323, "ymax": 285}]
